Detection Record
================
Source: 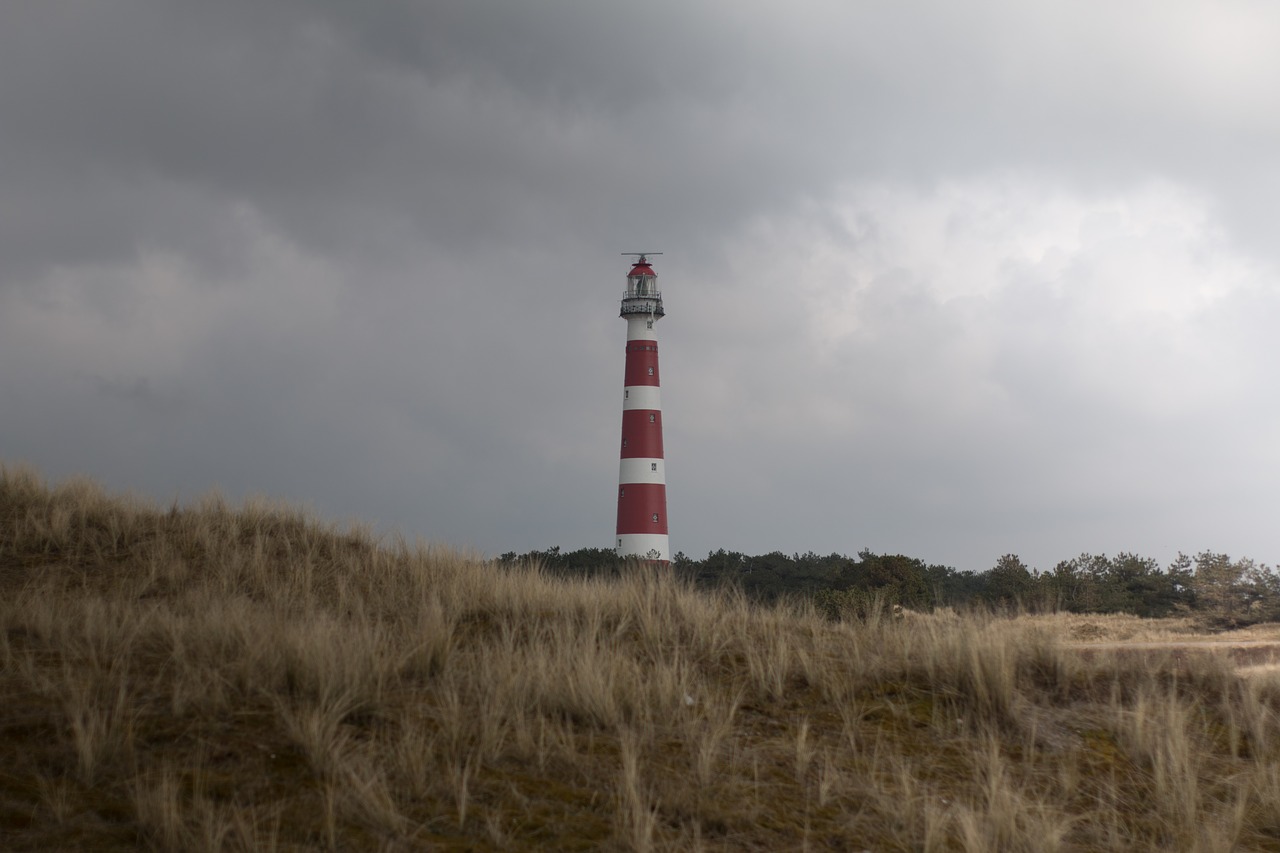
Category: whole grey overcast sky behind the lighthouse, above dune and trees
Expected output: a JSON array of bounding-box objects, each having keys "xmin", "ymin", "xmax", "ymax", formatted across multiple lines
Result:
[{"xmin": 0, "ymin": 0, "xmax": 1280, "ymax": 570}]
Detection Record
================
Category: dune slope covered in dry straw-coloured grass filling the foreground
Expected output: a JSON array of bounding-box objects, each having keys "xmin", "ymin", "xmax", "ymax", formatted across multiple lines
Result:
[{"xmin": 0, "ymin": 469, "xmax": 1280, "ymax": 850}]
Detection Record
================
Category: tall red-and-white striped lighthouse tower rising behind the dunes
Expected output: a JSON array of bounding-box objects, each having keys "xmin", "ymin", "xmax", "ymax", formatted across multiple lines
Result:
[{"xmin": 617, "ymin": 252, "xmax": 671, "ymax": 562}]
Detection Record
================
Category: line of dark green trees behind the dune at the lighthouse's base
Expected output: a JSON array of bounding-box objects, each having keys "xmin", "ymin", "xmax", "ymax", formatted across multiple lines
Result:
[{"xmin": 497, "ymin": 547, "xmax": 1280, "ymax": 626}]
